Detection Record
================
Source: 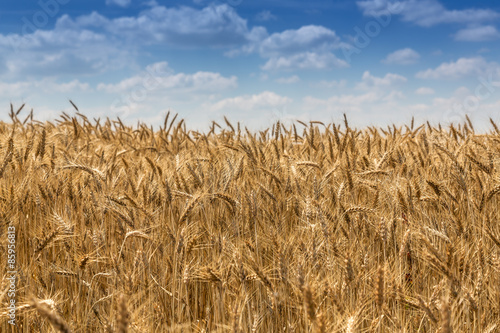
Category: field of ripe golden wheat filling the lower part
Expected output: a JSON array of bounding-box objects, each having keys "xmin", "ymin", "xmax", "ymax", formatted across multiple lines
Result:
[{"xmin": 0, "ymin": 110, "xmax": 500, "ymax": 332}]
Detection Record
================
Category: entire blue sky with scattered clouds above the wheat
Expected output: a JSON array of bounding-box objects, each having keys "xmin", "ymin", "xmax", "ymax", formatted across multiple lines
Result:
[{"xmin": 0, "ymin": 0, "xmax": 500, "ymax": 130}]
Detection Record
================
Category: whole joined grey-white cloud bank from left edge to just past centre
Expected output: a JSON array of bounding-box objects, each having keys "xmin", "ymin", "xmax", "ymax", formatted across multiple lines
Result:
[{"xmin": 0, "ymin": 3, "xmax": 267, "ymax": 79}]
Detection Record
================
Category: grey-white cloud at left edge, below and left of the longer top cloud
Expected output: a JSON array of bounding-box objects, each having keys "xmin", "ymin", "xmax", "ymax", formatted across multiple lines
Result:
[{"xmin": 0, "ymin": 20, "xmax": 133, "ymax": 79}]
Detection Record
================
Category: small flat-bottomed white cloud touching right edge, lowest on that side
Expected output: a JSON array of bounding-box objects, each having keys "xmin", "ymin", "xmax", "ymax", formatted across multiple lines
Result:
[{"xmin": 416, "ymin": 57, "xmax": 500, "ymax": 80}]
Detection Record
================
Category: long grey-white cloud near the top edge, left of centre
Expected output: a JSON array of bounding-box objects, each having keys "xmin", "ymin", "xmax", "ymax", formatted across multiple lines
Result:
[{"xmin": 56, "ymin": 4, "xmax": 262, "ymax": 48}]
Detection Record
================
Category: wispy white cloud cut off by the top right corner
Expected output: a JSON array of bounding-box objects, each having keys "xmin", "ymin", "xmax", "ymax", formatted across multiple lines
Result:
[{"xmin": 356, "ymin": 0, "xmax": 500, "ymax": 27}]
